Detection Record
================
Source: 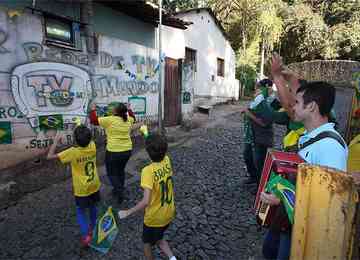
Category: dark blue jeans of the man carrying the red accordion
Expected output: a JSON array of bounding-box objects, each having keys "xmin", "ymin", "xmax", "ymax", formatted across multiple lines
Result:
[{"xmin": 262, "ymin": 230, "xmax": 291, "ymax": 260}]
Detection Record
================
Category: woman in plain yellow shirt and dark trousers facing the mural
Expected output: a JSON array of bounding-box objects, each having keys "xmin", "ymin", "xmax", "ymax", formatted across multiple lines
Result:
[{"xmin": 90, "ymin": 103, "xmax": 135, "ymax": 203}]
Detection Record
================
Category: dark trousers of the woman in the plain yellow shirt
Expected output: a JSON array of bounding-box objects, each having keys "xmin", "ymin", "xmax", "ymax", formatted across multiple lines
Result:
[{"xmin": 105, "ymin": 151, "xmax": 131, "ymax": 197}]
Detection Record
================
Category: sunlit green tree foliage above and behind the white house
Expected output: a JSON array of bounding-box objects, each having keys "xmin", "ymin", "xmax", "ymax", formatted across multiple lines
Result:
[{"xmin": 163, "ymin": 0, "xmax": 360, "ymax": 79}]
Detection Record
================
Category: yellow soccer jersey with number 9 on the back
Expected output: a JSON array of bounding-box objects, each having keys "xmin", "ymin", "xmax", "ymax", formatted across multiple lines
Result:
[{"xmin": 58, "ymin": 141, "xmax": 100, "ymax": 197}]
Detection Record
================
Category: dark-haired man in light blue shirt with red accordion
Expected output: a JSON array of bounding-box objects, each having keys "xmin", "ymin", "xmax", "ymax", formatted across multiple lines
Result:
[{"xmin": 261, "ymin": 82, "xmax": 348, "ymax": 260}]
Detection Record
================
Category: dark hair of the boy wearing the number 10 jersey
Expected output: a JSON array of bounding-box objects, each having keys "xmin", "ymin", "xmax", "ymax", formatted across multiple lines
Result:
[{"xmin": 145, "ymin": 133, "xmax": 168, "ymax": 162}]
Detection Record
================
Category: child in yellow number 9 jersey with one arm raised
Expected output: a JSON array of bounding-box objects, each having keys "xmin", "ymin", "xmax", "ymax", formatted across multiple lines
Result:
[{"xmin": 47, "ymin": 125, "xmax": 100, "ymax": 247}]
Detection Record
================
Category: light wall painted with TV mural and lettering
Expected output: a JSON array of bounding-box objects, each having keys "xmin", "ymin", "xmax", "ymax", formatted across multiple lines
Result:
[{"xmin": 0, "ymin": 10, "xmax": 159, "ymax": 170}]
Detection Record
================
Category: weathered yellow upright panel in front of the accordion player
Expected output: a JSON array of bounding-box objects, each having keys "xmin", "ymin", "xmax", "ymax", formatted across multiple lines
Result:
[{"xmin": 291, "ymin": 164, "xmax": 358, "ymax": 260}]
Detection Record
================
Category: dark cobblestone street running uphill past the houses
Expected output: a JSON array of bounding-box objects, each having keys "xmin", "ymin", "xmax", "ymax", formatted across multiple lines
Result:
[{"xmin": 0, "ymin": 102, "xmax": 284, "ymax": 259}]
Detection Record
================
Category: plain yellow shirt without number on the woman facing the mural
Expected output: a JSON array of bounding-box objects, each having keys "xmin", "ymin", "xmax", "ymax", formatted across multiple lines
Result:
[{"xmin": 98, "ymin": 116, "xmax": 134, "ymax": 152}]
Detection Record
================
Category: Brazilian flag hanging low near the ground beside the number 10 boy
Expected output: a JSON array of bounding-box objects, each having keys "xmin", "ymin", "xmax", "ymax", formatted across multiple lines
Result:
[{"xmin": 90, "ymin": 207, "xmax": 118, "ymax": 254}]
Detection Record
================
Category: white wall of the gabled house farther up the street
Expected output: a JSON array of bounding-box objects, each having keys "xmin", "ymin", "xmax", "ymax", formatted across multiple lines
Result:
[{"xmin": 177, "ymin": 10, "xmax": 239, "ymax": 105}]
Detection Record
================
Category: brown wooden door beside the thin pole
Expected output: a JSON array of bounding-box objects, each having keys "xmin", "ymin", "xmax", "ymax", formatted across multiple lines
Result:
[{"xmin": 164, "ymin": 58, "xmax": 181, "ymax": 126}]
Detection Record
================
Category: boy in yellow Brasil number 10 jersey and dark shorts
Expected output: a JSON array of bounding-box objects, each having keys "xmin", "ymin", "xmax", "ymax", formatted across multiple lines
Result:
[{"xmin": 119, "ymin": 134, "xmax": 176, "ymax": 260}]
